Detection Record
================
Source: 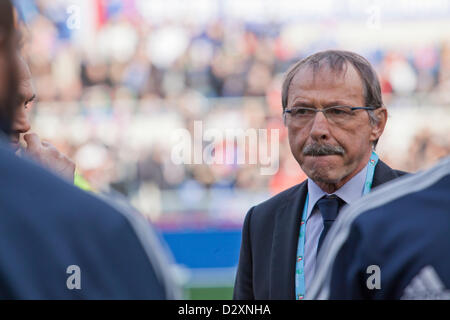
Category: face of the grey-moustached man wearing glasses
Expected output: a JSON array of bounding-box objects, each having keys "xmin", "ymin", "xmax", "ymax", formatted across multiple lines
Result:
[{"xmin": 286, "ymin": 65, "xmax": 385, "ymax": 188}]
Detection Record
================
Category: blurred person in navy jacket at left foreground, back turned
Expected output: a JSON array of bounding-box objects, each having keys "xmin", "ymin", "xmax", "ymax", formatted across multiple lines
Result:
[{"xmin": 0, "ymin": 0, "xmax": 178, "ymax": 299}]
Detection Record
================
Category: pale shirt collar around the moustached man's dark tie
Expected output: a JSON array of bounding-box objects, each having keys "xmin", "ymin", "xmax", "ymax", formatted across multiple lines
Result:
[{"xmin": 306, "ymin": 165, "xmax": 367, "ymax": 220}]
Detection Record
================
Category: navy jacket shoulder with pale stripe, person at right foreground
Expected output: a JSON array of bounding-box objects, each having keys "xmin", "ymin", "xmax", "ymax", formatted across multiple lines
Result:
[{"xmin": 307, "ymin": 157, "xmax": 450, "ymax": 300}]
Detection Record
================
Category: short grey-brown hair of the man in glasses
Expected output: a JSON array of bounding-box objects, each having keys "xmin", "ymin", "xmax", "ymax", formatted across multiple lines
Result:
[{"xmin": 281, "ymin": 50, "xmax": 384, "ymax": 147}]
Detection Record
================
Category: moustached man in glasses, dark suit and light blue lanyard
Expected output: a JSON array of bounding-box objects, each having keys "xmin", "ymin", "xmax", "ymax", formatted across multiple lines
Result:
[{"xmin": 234, "ymin": 50, "xmax": 403, "ymax": 300}]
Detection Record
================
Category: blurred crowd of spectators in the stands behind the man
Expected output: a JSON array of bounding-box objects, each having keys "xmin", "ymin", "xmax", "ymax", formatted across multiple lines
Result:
[{"xmin": 17, "ymin": 0, "xmax": 450, "ymax": 221}]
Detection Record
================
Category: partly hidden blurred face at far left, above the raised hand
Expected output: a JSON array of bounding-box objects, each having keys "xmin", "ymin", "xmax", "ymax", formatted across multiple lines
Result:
[{"xmin": 11, "ymin": 58, "xmax": 36, "ymax": 149}]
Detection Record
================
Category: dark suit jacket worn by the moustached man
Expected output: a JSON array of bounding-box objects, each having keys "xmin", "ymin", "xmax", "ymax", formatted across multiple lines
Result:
[{"xmin": 233, "ymin": 161, "xmax": 405, "ymax": 300}]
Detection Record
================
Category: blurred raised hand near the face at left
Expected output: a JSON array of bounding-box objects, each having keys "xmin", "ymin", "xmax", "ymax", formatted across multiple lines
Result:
[{"xmin": 23, "ymin": 133, "xmax": 75, "ymax": 182}]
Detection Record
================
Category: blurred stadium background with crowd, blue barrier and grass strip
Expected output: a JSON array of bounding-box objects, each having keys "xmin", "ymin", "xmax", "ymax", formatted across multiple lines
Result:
[{"xmin": 15, "ymin": 0, "xmax": 450, "ymax": 299}]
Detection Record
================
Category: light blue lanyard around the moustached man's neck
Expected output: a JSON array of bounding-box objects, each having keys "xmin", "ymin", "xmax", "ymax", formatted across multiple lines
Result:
[{"xmin": 295, "ymin": 151, "xmax": 378, "ymax": 300}]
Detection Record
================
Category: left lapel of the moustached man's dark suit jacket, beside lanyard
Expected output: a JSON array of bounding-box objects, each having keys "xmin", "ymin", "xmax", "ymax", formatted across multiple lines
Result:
[{"xmin": 269, "ymin": 182, "xmax": 307, "ymax": 300}]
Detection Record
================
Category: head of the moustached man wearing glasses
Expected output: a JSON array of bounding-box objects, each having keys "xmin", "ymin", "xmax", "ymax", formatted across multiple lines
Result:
[{"xmin": 282, "ymin": 50, "xmax": 387, "ymax": 189}]
